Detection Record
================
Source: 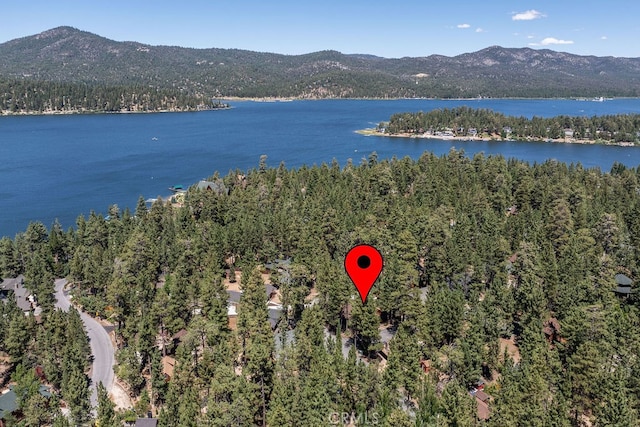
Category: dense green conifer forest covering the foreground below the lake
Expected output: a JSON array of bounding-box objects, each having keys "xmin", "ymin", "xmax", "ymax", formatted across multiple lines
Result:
[{"xmin": 0, "ymin": 150, "xmax": 640, "ymax": 427}]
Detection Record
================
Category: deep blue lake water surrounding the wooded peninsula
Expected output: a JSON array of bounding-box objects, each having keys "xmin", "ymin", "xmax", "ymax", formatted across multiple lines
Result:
[{"xmin": 0, "ymin": 99, "xmax": 640, "ymax": 237}]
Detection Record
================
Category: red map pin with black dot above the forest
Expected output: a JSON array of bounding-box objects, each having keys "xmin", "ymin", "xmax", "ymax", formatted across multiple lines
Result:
[{"xmin": 344, "ymin": 245, "xmax": 382, "ymax": 304}]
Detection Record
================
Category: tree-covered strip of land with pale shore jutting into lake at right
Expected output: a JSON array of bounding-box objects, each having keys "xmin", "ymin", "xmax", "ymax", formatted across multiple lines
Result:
[{"xmin": 359, "ymin": 107, "xmax": 640, "ymax": 146}]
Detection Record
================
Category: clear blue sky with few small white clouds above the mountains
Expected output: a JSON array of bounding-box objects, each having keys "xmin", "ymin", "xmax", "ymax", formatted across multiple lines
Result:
[{"xmin": 0, "ymin": 0, "xmax": 640, "ymax": 58}]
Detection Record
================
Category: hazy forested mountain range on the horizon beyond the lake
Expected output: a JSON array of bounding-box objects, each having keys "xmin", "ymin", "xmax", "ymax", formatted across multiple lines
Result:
[{"xmin": 0, "ymin": 27, "xmax": 640, "ymax": 98}]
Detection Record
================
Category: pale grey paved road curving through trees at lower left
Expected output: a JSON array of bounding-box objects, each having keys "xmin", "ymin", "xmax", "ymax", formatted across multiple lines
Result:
[{"xmin": 56, "ymin": 279, "xmax": 114, "ymax": 408}]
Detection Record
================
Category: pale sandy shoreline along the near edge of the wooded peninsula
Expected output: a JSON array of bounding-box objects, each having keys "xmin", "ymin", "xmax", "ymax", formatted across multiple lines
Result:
[{"xmin": 355, "ymin": 128, "xmax": 640, "ymax": 147}]
